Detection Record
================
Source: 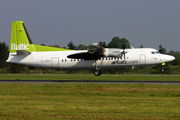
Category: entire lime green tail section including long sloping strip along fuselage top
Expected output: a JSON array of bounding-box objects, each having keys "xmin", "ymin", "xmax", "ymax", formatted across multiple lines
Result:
[{"xmin": 10, "ymin": 21, "xmax": 69, "ymax": 53}]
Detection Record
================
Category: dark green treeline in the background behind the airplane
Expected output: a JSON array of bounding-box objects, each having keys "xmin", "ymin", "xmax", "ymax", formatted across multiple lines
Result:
[{"xmin": 0, "ymin": 37, "xmax": 180, "ymax": 74}]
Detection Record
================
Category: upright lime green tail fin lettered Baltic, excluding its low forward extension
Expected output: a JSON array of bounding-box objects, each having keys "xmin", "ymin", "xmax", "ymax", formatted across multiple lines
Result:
[{"xmin": 10, "ymin": 21, "xmax": 35, "ymax": 53}]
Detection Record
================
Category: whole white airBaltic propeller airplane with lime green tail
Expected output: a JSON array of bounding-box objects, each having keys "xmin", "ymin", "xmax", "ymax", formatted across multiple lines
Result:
[{"xmin": 7, "ymin": 21, "xmax": 175, "ymax": 76}]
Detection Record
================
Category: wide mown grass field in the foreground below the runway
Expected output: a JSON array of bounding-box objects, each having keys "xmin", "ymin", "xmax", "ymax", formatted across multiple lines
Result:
[{"xmin": 0, "ymin": 83, "xmax": 180, "ymax": 120}]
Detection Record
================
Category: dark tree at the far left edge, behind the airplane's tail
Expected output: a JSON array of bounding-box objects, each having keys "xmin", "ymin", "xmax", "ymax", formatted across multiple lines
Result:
[{"xmin": 0, "ymin": 42, "xmax": 9, "ymax": 71}]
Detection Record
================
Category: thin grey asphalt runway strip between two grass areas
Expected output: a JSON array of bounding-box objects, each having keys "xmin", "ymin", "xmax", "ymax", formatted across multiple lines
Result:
[{"xmin": 0, "ymin": 80, "xmax": 180, "ymax": 85}]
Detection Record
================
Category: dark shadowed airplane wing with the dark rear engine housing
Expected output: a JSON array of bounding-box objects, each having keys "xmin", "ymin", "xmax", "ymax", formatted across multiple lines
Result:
[{"xmin": 67, "ymin": 43, "xmax": 105, "ymax": 60}]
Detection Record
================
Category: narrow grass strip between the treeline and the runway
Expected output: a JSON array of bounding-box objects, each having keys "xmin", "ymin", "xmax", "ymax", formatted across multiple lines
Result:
[{"xmin": 0, "ymin": 74, "xmax": 180, "ymax": 81}]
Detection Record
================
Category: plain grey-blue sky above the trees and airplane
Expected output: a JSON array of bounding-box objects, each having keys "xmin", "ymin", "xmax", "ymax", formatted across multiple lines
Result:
[{"xmin": 0, "ymin": 0, "xmax": 180, "ymax": 52}]
